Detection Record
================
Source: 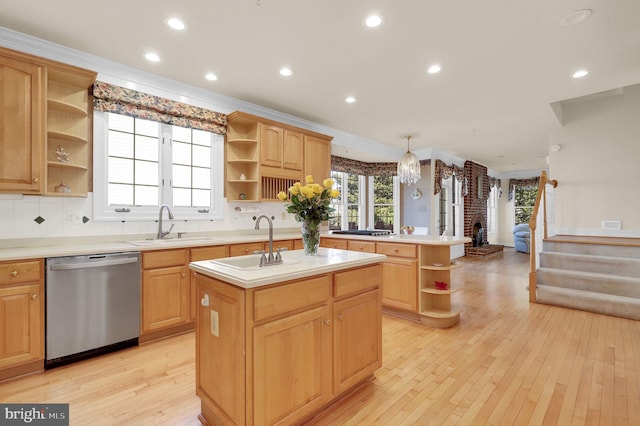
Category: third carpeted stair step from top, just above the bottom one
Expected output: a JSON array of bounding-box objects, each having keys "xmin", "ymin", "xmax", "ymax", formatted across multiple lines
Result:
[{"xmin": 536, "ymin": 267, "xmax": 640, "ymax": 300}]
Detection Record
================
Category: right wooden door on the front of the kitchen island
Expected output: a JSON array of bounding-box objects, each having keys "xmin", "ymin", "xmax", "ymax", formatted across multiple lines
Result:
[{"xmin": 333, "ymin": 289, "xmax": 382, "ymax": 394}]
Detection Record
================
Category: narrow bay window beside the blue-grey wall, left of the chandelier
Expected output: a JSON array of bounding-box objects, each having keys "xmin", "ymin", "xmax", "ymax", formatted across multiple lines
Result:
[{"xmin": 369, "ymin": 176, "xmax": 400, "ymax": 233}]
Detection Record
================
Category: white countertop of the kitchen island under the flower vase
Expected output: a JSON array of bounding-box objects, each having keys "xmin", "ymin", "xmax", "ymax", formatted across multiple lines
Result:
[{"xmin": 189, "ymin": 247, "xmax": 386, "ymax": 288}]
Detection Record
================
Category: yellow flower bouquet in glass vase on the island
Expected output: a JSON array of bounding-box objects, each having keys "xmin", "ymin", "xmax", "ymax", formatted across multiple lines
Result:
[{"xmin": 278, "ymin": 175, "xmax": 340, "ymax": 255}]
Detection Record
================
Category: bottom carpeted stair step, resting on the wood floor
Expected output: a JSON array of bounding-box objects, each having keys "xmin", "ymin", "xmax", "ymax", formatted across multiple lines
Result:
[{"xmin": 536, "ymin": 285, "xmax": 640, "ymax": 320}]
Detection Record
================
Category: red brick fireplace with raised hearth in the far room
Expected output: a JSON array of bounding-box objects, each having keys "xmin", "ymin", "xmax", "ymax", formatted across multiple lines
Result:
[{"xmin": 464, "ymin": 161, "xmax": 503, "ymax": 257}]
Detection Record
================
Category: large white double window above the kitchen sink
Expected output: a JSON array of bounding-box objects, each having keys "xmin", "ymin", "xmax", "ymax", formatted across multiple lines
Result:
[{"xmin": 94, "ymin": 111, "xmax": 224, "ymax": 220}]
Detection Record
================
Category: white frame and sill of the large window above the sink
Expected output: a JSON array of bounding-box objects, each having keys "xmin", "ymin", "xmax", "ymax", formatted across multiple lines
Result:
[{"xmin": 93, "ymin": 110, "xmax": 224, "ymax": 221}]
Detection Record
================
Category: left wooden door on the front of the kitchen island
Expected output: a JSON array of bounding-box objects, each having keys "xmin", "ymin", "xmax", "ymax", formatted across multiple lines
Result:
[{"xmin": 253, "ymin": 305, "xmax": 332, "ymax": 425}]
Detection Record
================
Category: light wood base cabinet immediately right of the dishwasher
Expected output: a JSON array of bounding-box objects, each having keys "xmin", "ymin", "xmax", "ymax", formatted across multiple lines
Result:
[{"xmin": 140, "ymin": 249, "xmax": 191, "ymax": 340}]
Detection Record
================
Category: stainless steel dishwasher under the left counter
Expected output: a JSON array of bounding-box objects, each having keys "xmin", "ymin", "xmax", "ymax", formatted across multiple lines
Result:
[{"xmin": 45, "ymin": 252, "xmax": 140, "ymax": 368}]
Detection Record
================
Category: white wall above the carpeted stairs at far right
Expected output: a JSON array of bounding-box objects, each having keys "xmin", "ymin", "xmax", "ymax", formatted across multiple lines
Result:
[{"xmin": 549, "ymin": 85, "xmax": 640, "ymax": 237}]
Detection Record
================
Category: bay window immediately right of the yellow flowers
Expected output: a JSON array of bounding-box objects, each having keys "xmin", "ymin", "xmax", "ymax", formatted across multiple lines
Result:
[{"xmin": 329, "ymin": 171, "xmax": 365, "ymax": 230}]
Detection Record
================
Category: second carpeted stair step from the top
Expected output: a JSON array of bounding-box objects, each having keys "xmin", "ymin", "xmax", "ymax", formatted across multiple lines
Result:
[{"xmin": 540, "ymin": 251, "xmax": 640, "ymax": 277}]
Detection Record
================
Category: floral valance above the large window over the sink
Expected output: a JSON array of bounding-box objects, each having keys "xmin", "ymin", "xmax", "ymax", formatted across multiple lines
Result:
[{"xmin": 93, "ymin": 81, "xmax": 227, "ymax": 135}]
